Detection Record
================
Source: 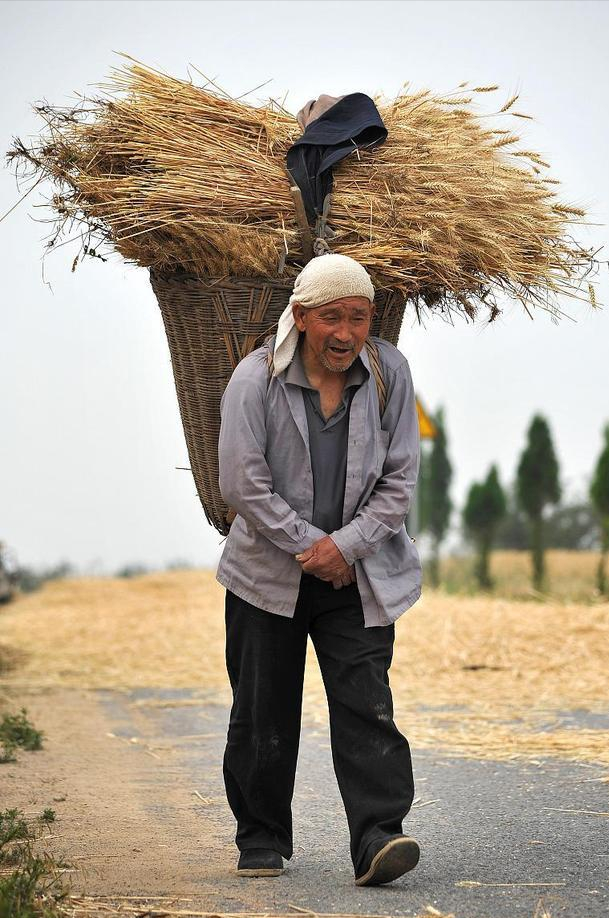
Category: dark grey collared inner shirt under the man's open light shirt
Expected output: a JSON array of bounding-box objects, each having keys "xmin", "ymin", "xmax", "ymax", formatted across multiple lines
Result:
[{"xmin": 285, "ymin": 335, "xmax": 366, "ymax": 532}]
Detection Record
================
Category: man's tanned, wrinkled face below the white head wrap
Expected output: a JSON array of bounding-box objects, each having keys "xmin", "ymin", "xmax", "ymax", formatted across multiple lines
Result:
[{"xmin": 292, "ymin": 296, "xmax": 374, "ymax": 373}]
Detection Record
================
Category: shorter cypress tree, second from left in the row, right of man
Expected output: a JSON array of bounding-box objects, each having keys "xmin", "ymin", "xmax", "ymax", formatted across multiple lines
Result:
[{"xmin": 463, "ymin": 465, "xmax": 507, "ymax": 590}]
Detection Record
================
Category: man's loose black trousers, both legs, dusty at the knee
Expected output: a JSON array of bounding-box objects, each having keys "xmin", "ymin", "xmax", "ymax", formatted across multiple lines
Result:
[{"xmin": 223, "ymin": 572, "xmax": 414, "ymax": 875}]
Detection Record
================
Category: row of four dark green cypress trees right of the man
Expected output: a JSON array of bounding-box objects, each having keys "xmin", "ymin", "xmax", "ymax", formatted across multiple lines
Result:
[{"xmin": 420, "ymin": 411, "xmax": 609, "ymax": 595}]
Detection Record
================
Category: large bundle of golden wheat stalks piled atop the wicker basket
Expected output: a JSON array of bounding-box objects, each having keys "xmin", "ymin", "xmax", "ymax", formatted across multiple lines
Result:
[{"xmin": 8, "ymin": 55, "xmax": 596, "ymax": 318}]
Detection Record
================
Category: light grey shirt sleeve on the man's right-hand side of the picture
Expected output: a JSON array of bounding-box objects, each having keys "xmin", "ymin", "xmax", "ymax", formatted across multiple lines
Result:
[{"xmin": 330, "ymin": 361, "xmax": 420, "ymax": 564}]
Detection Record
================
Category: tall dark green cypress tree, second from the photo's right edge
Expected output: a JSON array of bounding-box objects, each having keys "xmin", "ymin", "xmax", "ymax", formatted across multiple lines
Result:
[{"xmin": 516, "ymin": 414, "xmax": 560, "ymax": 590}]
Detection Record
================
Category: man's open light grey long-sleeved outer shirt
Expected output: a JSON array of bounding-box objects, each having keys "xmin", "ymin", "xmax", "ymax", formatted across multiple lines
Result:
[{"xmin": 216, "ymin": 337, "xmax": 421, "ymax": 628}]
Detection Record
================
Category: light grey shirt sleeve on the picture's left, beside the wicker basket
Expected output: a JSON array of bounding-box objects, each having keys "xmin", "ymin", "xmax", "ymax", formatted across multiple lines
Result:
[{"xmin": 218, "ymin": 366, "xmax": 327, "ymax": 555}]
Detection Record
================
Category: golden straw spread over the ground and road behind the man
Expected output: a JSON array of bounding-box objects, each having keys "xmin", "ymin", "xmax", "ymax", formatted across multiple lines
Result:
[{"xmin": 0, "ymin": 552, "xmax": 609, "ymax": 766}]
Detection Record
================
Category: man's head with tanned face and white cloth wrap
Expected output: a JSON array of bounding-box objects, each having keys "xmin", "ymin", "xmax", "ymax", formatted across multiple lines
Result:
[{"xmin": 290, "ymin": 254, "xmax": 374, "ymax": 373}]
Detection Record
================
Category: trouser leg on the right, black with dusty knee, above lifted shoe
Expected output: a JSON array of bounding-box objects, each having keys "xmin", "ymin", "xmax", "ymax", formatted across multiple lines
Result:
[{"xmin": 310, "ymin": 581, "xmax": 414, "ymax": 875}]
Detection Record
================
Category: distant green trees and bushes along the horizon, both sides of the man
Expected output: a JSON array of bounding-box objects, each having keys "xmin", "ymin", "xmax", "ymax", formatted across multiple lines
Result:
[{"xmin": 0, "ymin": 418, "xmax": 609, "ymax": 603}]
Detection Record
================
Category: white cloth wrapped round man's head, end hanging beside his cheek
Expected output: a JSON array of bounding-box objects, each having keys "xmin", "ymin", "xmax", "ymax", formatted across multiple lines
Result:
[{"xmin": 273, "ymin": 253, "xmax": 374, "ymax": 376}]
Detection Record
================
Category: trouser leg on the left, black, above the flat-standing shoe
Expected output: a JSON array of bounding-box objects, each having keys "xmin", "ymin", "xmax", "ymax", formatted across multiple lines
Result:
[{"xmin": 223, "ymin": 590, "xmax": 307, "ymax": 859}]
